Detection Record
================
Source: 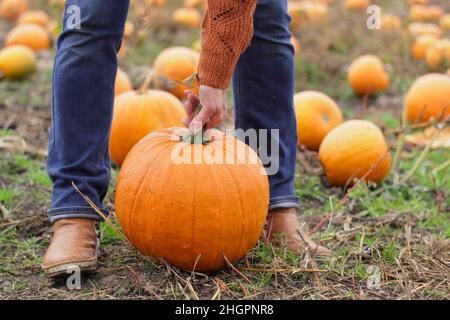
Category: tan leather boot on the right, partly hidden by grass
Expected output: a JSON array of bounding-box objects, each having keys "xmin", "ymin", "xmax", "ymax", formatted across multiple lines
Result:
[{"xmin": 267, "ymin": 208, "xmax": 331, "ymax": 256}]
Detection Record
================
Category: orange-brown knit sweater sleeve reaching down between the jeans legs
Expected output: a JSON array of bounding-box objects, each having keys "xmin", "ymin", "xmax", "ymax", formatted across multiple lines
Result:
[{"xmin": 198, "ymin": 0, "xmax": 257, "ymax": 89}]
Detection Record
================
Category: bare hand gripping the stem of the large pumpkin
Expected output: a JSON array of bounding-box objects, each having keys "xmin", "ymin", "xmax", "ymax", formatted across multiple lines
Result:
[{"xmin": 184, "ymin": 86, "xmax": 227, "ymax": 134}]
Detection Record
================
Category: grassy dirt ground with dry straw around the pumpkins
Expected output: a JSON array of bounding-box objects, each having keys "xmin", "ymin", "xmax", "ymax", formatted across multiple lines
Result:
[{"xmin": 0, "ymin": 1, "xmax": 450, "ymax": 299}]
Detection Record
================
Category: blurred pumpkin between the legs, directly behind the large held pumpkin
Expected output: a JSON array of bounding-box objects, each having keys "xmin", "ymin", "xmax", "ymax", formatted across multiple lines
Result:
[{"xmin": 109, "ymin": 90, "xmax": 186, "ymax": 165}]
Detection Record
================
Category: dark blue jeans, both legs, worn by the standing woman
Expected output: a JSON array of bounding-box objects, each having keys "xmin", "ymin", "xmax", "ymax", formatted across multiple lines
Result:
[{"xmin": 48, "ymin": 0, "xmax": 298, "ymax": 222}]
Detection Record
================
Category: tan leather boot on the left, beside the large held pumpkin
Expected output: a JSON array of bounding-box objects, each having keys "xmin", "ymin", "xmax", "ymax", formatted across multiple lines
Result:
[{"xmin": 42, "ymin": 218, "xmax": 100, "ymax": 277}]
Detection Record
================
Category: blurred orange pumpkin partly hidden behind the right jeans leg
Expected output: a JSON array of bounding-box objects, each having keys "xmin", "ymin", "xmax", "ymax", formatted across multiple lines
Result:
[{"xmin": 294, "ymin": 91, "xmax": 343, "ymax": 150}]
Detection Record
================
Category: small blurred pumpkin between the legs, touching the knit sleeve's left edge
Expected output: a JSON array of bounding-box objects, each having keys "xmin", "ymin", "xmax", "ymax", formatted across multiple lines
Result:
[{"xmin": 153, "ymin": 47, "xmax": 200, "ymax": 99}]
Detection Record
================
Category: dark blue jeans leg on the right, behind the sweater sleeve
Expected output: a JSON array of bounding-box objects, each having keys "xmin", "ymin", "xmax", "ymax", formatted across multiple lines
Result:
[{"xmin": 233, "ymin": 0, "xmax": 299, "ymax": 209}]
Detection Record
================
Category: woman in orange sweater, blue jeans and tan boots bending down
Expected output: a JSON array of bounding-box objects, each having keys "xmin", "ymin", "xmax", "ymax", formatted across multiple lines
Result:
[{"xmin": 42, "ymin": 0, "xmax": 330, "ymax": 275}]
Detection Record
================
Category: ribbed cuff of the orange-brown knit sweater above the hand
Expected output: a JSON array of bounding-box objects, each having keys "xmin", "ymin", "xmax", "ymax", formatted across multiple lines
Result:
[{"xmin": 198, "ymin": 51, "xmax": 238, "ymax": 89}]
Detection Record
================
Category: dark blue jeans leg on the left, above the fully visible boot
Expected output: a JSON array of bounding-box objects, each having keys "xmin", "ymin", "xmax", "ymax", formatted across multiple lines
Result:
[{"xmin": 47, "ymin": 0, "xmax": 129, "ymax": 222}]
